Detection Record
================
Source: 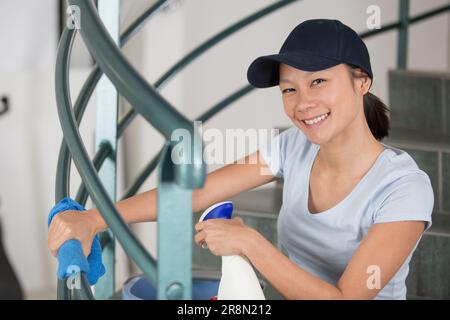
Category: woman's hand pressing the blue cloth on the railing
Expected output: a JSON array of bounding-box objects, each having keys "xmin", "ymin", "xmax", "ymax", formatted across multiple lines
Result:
[{"xmin": 48, "ymin": 210, "xmax": 99, "ymax": 257}]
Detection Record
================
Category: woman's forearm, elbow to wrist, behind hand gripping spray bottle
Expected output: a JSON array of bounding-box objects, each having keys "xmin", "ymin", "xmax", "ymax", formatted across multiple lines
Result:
[{"xmin": 243, "ymin": 230, "xmax": 343, "ymax": 300}]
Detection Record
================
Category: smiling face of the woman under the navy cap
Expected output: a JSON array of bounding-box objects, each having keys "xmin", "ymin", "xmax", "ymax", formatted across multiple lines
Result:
[{"xmin": 279, "ymin": 63, "xmax": 370, "ymax": 145}]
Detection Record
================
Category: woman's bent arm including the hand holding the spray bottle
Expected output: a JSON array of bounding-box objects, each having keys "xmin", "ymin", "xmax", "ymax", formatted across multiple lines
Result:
[{"xmin": 195, "ymin": 218, "xmax": 424, "ymax": 300}]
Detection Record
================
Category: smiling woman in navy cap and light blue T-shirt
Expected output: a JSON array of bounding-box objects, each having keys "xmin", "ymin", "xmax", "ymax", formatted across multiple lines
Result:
[{"xmin": 49, "ymin": 19, "xmax": 434, "ymax": 299}]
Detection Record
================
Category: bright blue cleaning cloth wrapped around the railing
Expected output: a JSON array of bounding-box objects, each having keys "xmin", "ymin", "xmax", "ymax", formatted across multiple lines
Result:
[{"xmin": 48, "ymin": 198, "xmax": 106, "ymax": 285}]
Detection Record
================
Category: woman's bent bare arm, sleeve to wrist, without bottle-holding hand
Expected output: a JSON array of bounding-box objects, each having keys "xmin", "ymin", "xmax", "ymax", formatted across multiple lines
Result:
[{"xmin": 243, "ymin": 221, "xmax": 425, "ymax": 299}]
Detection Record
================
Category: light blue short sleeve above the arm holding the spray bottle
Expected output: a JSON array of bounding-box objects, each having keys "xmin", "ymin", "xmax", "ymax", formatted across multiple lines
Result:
[{"xmin": 374, "ymin": 171, "xmax": 434, "ymax": 231}]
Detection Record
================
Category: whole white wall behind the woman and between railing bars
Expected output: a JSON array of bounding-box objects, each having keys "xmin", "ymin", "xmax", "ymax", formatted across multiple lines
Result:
[{"xmin": 0, "ymin": 0, "xmax": 449, "ymax": 293}]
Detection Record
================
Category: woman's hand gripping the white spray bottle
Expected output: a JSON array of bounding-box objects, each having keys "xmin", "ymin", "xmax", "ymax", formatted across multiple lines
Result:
[{"xmin": 194, "ymin": 218, "xmax": 255, "ymax": 256}]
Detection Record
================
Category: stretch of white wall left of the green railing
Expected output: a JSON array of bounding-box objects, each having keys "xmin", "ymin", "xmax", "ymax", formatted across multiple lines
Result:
[{"xmin": 0, "ymin": 0, "xmax": 61, "ymax": 292}]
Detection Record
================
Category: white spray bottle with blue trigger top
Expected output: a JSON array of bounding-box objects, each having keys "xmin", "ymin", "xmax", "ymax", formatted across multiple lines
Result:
[{"xmin": 199, "ymin": 201, "xmax": 265, "ymax": 300}]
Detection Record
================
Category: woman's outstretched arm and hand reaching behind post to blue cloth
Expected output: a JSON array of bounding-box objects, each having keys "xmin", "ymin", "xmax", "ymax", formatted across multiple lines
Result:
[{"xmin": 48, "ymin": 152, "xmax": 275, "ymax": 256}]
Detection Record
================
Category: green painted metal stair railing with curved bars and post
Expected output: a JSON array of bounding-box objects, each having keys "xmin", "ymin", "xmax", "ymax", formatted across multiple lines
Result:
[{"xmin": 55, "ymin": 0, "xmax": 450, "ymax": 299}]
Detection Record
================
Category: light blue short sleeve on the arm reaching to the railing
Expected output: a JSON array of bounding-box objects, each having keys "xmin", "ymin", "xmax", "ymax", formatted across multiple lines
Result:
[{"xmin": 259, "ymin": 127, "xmax": 297, "ymax": 178}]
